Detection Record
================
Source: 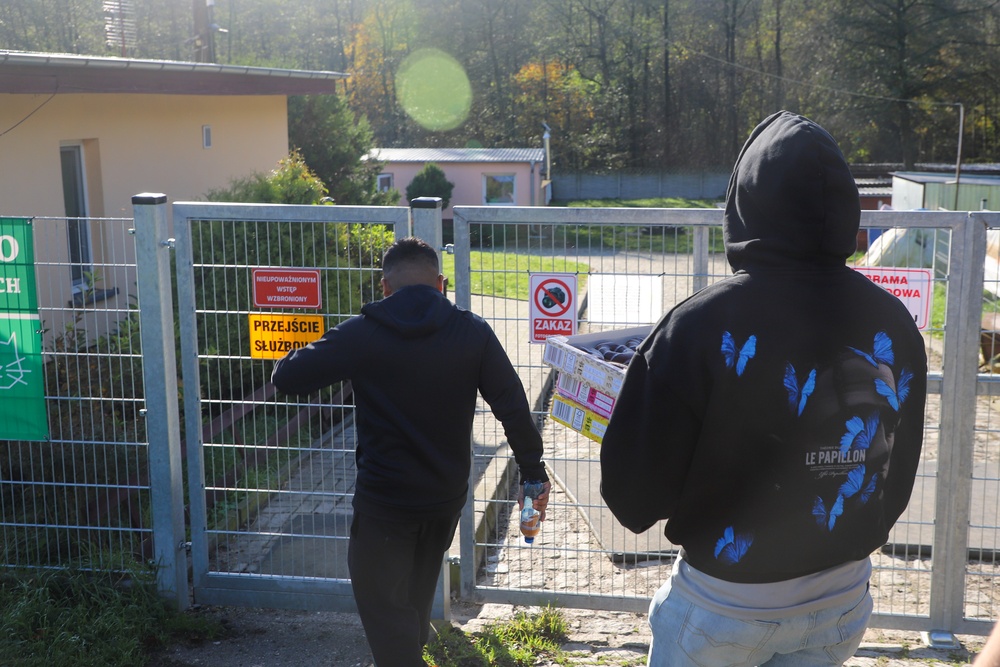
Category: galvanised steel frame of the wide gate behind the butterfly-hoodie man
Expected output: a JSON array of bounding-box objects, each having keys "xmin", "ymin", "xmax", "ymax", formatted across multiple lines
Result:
[{"xmin": 454, "ymin": 206, "xmax": 1000, "ymax": 634}]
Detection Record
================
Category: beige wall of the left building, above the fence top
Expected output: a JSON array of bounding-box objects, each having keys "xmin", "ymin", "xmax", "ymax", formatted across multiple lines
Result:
[{"xmin": 0, "ymin": 94, "xmax": 288, "ymax": 217}]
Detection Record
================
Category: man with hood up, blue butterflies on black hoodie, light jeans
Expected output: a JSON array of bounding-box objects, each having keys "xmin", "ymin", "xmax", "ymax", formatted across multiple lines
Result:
[{"xmin": 601, "ymin": 111, "xmax": 927, "ymax": 667}]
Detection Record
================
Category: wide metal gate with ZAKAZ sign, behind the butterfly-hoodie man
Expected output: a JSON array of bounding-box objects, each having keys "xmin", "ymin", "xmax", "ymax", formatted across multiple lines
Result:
[{"xmin": 454, "ymin": 207, "xmax": 1000, "ymax": 632}]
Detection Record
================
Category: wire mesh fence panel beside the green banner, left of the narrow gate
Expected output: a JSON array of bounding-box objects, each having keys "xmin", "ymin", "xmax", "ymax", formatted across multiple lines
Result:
[{"xmin": 0, "ymin": 218, "xmax": 146, "ymax": 569}]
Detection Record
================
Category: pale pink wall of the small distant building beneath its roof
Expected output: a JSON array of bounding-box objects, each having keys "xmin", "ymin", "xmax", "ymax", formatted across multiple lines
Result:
[{"xmin": 382, "ymin": 162, "xmax": 545, "ymax": 218}]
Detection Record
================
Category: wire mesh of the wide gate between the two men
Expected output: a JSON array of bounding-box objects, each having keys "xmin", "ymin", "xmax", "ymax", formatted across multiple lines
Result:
[{"xmin": 463, "ymin": 213, "xmax": 729, "ymax": 610}]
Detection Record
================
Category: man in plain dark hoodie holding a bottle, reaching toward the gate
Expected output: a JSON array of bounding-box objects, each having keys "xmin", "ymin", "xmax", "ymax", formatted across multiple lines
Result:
[{"xmin": 271, "ymin": 238, "xmax": 549, "ymax": 667}]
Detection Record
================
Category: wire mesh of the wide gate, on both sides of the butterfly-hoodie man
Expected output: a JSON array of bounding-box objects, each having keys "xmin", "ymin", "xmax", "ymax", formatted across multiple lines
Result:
[{"xmin": 456, "ymin": 208, "xmax": 997, "ymax": 627}]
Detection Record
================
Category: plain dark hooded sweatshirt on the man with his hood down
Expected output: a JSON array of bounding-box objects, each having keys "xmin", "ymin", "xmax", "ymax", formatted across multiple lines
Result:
[{"xmin": 271, "ymin": 285, "xmax": 548, "ymax": 520}]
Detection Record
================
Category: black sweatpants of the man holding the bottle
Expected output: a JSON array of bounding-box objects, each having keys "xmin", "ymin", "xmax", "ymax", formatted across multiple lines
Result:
[{"xmin": 347, "ymin": 510, "xmax": 459, "ymax": 667}]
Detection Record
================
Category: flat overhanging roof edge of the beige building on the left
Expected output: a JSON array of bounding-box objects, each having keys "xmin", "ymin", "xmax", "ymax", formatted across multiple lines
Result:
[{"xmin": 0, "ymin": 50, "xmax": 348, "ymax": 95}]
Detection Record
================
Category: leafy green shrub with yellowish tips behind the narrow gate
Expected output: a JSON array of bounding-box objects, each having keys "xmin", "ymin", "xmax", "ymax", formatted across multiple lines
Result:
[{"xmin": 192, "ymin": 151, "xmax": 392, "ymax": 401}]
